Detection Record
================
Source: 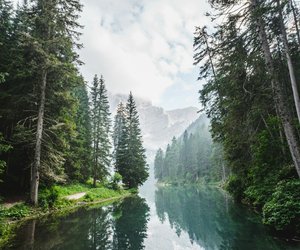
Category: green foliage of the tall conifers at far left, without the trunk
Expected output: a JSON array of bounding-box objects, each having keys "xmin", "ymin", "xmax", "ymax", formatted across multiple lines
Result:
[{"xmin": 0, "ymin": 0, "xmax": 95, "ymax": 196}]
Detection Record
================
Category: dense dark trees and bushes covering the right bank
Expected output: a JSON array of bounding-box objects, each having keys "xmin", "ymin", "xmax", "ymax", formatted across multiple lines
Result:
[{"xmin": 194, "ymin": 0, "xmax": 300, "ymax": 235}]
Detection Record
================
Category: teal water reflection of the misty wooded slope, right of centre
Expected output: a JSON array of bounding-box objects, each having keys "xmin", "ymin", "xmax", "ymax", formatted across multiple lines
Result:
[{"xmin": 155, "ymin": 187, "xmax": 280, "ymax": 250}]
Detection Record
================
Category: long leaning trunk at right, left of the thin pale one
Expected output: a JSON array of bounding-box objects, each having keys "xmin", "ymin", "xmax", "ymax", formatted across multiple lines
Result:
[{"xmin": 251, "ymin": 0, "xmax": 300, "ymax": 178}]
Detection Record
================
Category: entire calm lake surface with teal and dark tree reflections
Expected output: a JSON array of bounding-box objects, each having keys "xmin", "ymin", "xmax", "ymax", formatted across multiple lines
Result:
[{"xmin": 5, "ymin": 186, "xmax": 300, "ymax": 250}]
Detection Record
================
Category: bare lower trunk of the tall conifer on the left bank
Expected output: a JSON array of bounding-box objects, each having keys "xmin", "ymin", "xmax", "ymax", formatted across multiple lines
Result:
[{"xmin": 30, "ymin": 70, "xmax": 47, "ymax": 205}]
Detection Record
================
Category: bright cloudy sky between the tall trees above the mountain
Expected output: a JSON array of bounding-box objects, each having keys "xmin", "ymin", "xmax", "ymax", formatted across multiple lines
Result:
[{"xmin": 15, "ymin": 0, "xmax": 208, "ymax": 110}]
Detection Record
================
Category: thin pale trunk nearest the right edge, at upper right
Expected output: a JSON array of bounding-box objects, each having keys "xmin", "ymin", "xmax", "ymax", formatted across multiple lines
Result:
[{"xmin": 276, "ymin": 0, "xmax": 300, "ymax": 122}]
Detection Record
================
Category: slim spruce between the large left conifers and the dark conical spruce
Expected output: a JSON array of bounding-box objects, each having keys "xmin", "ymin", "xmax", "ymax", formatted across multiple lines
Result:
[{"xmin": 91, "ymin": 75, "xmax": 111, "ymax": 186}]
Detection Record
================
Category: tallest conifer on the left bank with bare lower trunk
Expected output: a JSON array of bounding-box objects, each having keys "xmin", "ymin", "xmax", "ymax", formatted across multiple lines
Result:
[{"xmin": 0, "ymin": 0, "xmax": 85, "ymax": 204}]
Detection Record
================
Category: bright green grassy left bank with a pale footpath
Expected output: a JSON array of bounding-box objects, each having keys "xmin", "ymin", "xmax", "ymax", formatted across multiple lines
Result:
[{"xmin": 0, "ymin": 184, "xmax": 136, "ymax": 248}]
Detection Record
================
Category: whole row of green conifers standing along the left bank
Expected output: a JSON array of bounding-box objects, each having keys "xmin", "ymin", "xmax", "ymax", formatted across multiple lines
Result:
[{"xmin": 0, "ymin": 0, "xmax": 148, "ymax": 204}]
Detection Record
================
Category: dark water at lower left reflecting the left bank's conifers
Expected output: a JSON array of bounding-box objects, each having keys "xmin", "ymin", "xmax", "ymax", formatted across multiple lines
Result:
[{"xmin": 11, "ymin": 196, "xmax": 149, "ymax": 250}]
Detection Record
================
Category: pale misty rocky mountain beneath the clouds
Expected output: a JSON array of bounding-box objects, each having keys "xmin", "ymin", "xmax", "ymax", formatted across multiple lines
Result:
[{"xmin": 108, "ymin": 93, "xmax": 199, "ymax": 158}]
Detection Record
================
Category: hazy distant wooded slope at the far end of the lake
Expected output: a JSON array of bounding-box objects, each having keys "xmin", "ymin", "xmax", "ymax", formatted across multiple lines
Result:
[{"xmin": 154, "ymin": 115, "xmax": 226, "ymax": 183}]
